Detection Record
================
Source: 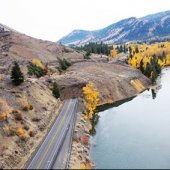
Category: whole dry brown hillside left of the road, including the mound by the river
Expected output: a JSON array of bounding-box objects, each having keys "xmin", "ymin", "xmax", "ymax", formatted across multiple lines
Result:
[{"xmin": 0, "ymin": 24, "xmax": 150, "ymax": 169}]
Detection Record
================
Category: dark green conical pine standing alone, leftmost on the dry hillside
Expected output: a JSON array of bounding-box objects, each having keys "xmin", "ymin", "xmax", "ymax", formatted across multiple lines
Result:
[{"xmin": 11, "ymin": 61, "xmax": 24, "ymax": 86}]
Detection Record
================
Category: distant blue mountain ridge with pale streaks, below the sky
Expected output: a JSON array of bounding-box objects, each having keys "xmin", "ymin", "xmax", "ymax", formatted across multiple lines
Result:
[{"xmin": 58, "ymin": 11, "xmax": 170, "ymax": 46}]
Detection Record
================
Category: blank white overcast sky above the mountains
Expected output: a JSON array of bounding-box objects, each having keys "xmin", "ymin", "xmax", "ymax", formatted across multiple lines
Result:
[{"xmin": 0, "ymin": 0, "xmax": 170, "ymax": 41}]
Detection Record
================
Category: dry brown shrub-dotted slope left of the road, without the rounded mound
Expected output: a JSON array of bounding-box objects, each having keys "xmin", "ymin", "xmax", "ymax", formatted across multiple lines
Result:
[{"xmin": 0, "ymin": 24, "xmax": 83, "ymax": 169}]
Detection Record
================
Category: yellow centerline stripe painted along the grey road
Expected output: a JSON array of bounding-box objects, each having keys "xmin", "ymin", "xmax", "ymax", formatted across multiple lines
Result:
[{"xmin": 36, "ymin": 102, "xmax": 71, "ymax": 169}]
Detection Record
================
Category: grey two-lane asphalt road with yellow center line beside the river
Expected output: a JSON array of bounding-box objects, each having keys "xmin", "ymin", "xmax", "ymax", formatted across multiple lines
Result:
[{"xmin": 27, "ymin": 99, "xmax": 78, "ymax": 169}]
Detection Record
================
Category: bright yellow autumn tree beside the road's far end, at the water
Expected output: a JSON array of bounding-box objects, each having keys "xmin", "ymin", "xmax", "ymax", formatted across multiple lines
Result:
[{"xmin": 83, "ymin": 83, "xmax": 99, "ymax": 119}]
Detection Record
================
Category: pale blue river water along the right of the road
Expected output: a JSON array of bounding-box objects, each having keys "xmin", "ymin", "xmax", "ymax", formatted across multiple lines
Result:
[{"xmin": 90, "ymin": 68, "xmax": 170, "ymax": 169}]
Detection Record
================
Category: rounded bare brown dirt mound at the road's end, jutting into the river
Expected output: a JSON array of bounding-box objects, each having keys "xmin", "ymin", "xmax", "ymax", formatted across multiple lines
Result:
[{"xmin": 53, "ymin": 62, "xmax": 150, "ymax": 105}]
